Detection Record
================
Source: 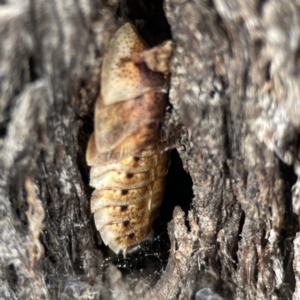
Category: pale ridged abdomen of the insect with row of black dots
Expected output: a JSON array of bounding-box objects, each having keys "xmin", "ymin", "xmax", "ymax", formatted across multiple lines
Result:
[{"xmin": 90, "ymin": 142, "xmax": 168, "ymax": 255}]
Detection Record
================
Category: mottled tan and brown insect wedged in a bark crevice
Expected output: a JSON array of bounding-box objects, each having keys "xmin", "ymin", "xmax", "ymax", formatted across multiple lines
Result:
[{"xmin": 86, "ymin": 23, "xmax": 172, "ymax": 255}]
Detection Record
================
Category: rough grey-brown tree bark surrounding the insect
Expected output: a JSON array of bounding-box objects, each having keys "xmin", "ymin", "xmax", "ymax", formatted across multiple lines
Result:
[{"xmin": 0, "ymin": 0, "xmax": 300, "ymax": 300}]
